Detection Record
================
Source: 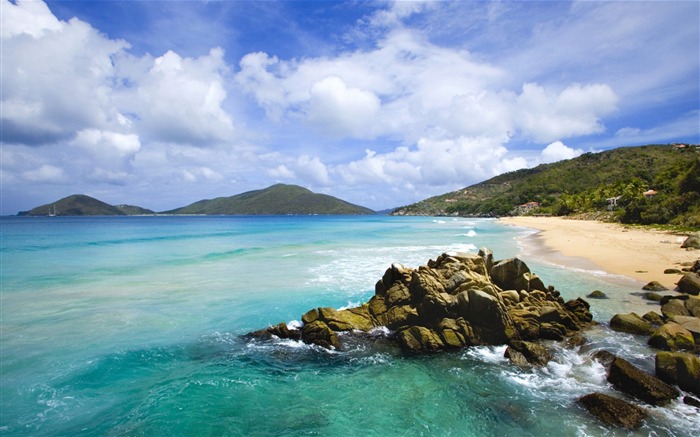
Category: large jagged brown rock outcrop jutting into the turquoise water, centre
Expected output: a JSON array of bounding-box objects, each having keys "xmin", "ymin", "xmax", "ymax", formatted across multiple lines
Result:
[{"xmin": 249, "ymin": 249, "xmax": 592, "ymax": 353}]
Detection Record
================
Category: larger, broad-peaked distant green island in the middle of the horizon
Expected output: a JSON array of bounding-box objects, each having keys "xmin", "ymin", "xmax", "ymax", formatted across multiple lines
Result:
[{"xmin": 163, "ymin": 184, "xmax": 374, "ymax": 215}]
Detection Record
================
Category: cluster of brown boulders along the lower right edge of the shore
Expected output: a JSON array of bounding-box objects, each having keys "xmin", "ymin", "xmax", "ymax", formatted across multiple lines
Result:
[{"xmin": 592, "ymin": 261, "xmax": 700, "ymax": 428}]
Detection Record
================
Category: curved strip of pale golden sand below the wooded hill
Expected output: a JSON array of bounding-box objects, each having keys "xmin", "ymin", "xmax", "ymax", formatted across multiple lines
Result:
[{"xmin": 500, "ymin": 217, "xmax": 700, "ymax": 290}]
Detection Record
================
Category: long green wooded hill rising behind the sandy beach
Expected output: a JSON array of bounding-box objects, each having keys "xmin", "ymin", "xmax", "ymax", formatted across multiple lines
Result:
[{"xmin": 392, "ymin": 145, "xmax": 700, "ymax": 226}]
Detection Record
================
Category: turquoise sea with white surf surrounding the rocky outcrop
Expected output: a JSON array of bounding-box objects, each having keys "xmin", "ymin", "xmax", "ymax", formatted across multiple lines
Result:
[{"xmin": 0, "ymin": 216, "xmax": 700, "ymax": 436}]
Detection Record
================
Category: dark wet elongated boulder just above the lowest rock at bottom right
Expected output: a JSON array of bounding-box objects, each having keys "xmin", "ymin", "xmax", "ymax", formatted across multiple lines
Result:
[{"xmin": 608, "ymin": 357, "xmax": 680, "ymax": 405}]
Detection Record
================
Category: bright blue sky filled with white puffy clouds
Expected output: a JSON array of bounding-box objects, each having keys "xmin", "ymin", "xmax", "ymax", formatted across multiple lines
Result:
[{"xmin": 0, "ymin": 0, "xmax": 700, "ymax": 215}]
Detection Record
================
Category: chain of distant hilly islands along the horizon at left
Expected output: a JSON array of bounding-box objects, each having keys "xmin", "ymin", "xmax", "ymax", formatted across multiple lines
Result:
[{"xmin": 18, "ymin": 184, "xmax": 375, "ymax": 216}]
